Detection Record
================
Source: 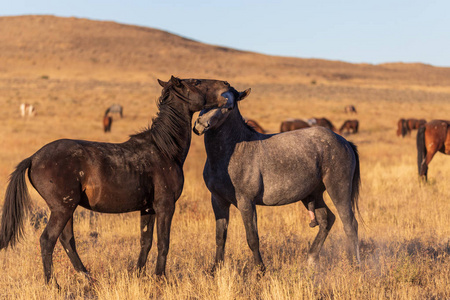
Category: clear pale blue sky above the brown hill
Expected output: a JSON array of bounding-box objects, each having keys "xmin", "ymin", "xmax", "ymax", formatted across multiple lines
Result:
[{"xmin": 0, "ymin": 0, "xmax": 450, "ymax": 67}]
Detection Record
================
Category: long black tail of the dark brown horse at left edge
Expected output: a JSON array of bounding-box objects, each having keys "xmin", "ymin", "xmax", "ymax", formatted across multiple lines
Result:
[{"xmin": 0, "ymin": 157, "xmax": 31, "ymax": 249}]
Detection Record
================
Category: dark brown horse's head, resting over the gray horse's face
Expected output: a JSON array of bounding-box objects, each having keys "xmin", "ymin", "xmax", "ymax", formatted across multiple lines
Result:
[{"xmin": 158, "ymin": 76, "xmax": 243, "ymax": 112}]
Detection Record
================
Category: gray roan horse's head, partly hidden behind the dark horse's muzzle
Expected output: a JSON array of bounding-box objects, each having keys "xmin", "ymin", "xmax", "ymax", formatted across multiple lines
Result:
[{"xmin": 194, "ymin": 89, "xmax": 251, "ymax": 135}]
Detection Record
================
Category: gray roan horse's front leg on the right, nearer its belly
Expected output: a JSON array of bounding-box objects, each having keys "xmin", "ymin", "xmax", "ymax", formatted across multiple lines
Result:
[{"xmin": 238, "ymin": 199, "xmax": 266, "ymax": 273}]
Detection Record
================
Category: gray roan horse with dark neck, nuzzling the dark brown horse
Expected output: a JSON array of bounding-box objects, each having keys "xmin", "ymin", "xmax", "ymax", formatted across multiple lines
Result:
[{"xmin": 194, "ymin": 90, "xmax": 360, "ymax": 271}]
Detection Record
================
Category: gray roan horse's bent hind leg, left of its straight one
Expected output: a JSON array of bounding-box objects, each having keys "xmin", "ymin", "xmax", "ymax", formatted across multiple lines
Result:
[{"xmin": 303, "ymin": 191, "xmax": 336, "ymax": 265}]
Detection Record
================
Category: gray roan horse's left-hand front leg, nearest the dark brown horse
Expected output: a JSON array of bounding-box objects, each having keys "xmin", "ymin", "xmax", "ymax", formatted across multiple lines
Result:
[{"xmin": 211, "ymin": 195, "xmax": 230, "ymax": 272}]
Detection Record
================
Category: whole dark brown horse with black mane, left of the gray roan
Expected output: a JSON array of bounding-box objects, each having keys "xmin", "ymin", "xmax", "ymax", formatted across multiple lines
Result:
[{"xmin": 0, "ymin": 76, "xmax": 235, "ymax": 284}]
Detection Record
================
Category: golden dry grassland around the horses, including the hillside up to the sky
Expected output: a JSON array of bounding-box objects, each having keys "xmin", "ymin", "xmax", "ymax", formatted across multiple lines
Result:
[{"xmin": 0, "ymin": 16, "xmax": 450, "ymax": 300}]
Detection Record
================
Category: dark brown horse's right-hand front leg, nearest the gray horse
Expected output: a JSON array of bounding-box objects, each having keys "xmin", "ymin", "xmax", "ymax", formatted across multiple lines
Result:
[{"xmin": 154, "ymin": 197, "xmax": 175, "ymax": 276}]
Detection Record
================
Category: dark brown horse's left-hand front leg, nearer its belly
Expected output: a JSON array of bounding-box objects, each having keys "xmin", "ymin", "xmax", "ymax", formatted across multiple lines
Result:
[{"xmin": 137, "ymin": 209, "xmax": 156, "ymax": 272}]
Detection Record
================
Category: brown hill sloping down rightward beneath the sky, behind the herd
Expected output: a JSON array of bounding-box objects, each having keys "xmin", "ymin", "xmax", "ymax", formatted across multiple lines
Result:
[{"xmin": 0, "ymin": 16, "xmax": 450, "ymax": 87}]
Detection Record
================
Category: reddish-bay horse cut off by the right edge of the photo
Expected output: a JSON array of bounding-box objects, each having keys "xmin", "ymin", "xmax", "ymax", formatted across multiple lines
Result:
[{"xmin": 417, "ymin": 120, "xmax": 450, "ymax": 181}]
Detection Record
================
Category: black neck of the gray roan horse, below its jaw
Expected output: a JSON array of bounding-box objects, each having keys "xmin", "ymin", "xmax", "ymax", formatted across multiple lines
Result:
[{"xmin": 205, "ymin": 107, "xmax": 250, "ymax": 160}]
